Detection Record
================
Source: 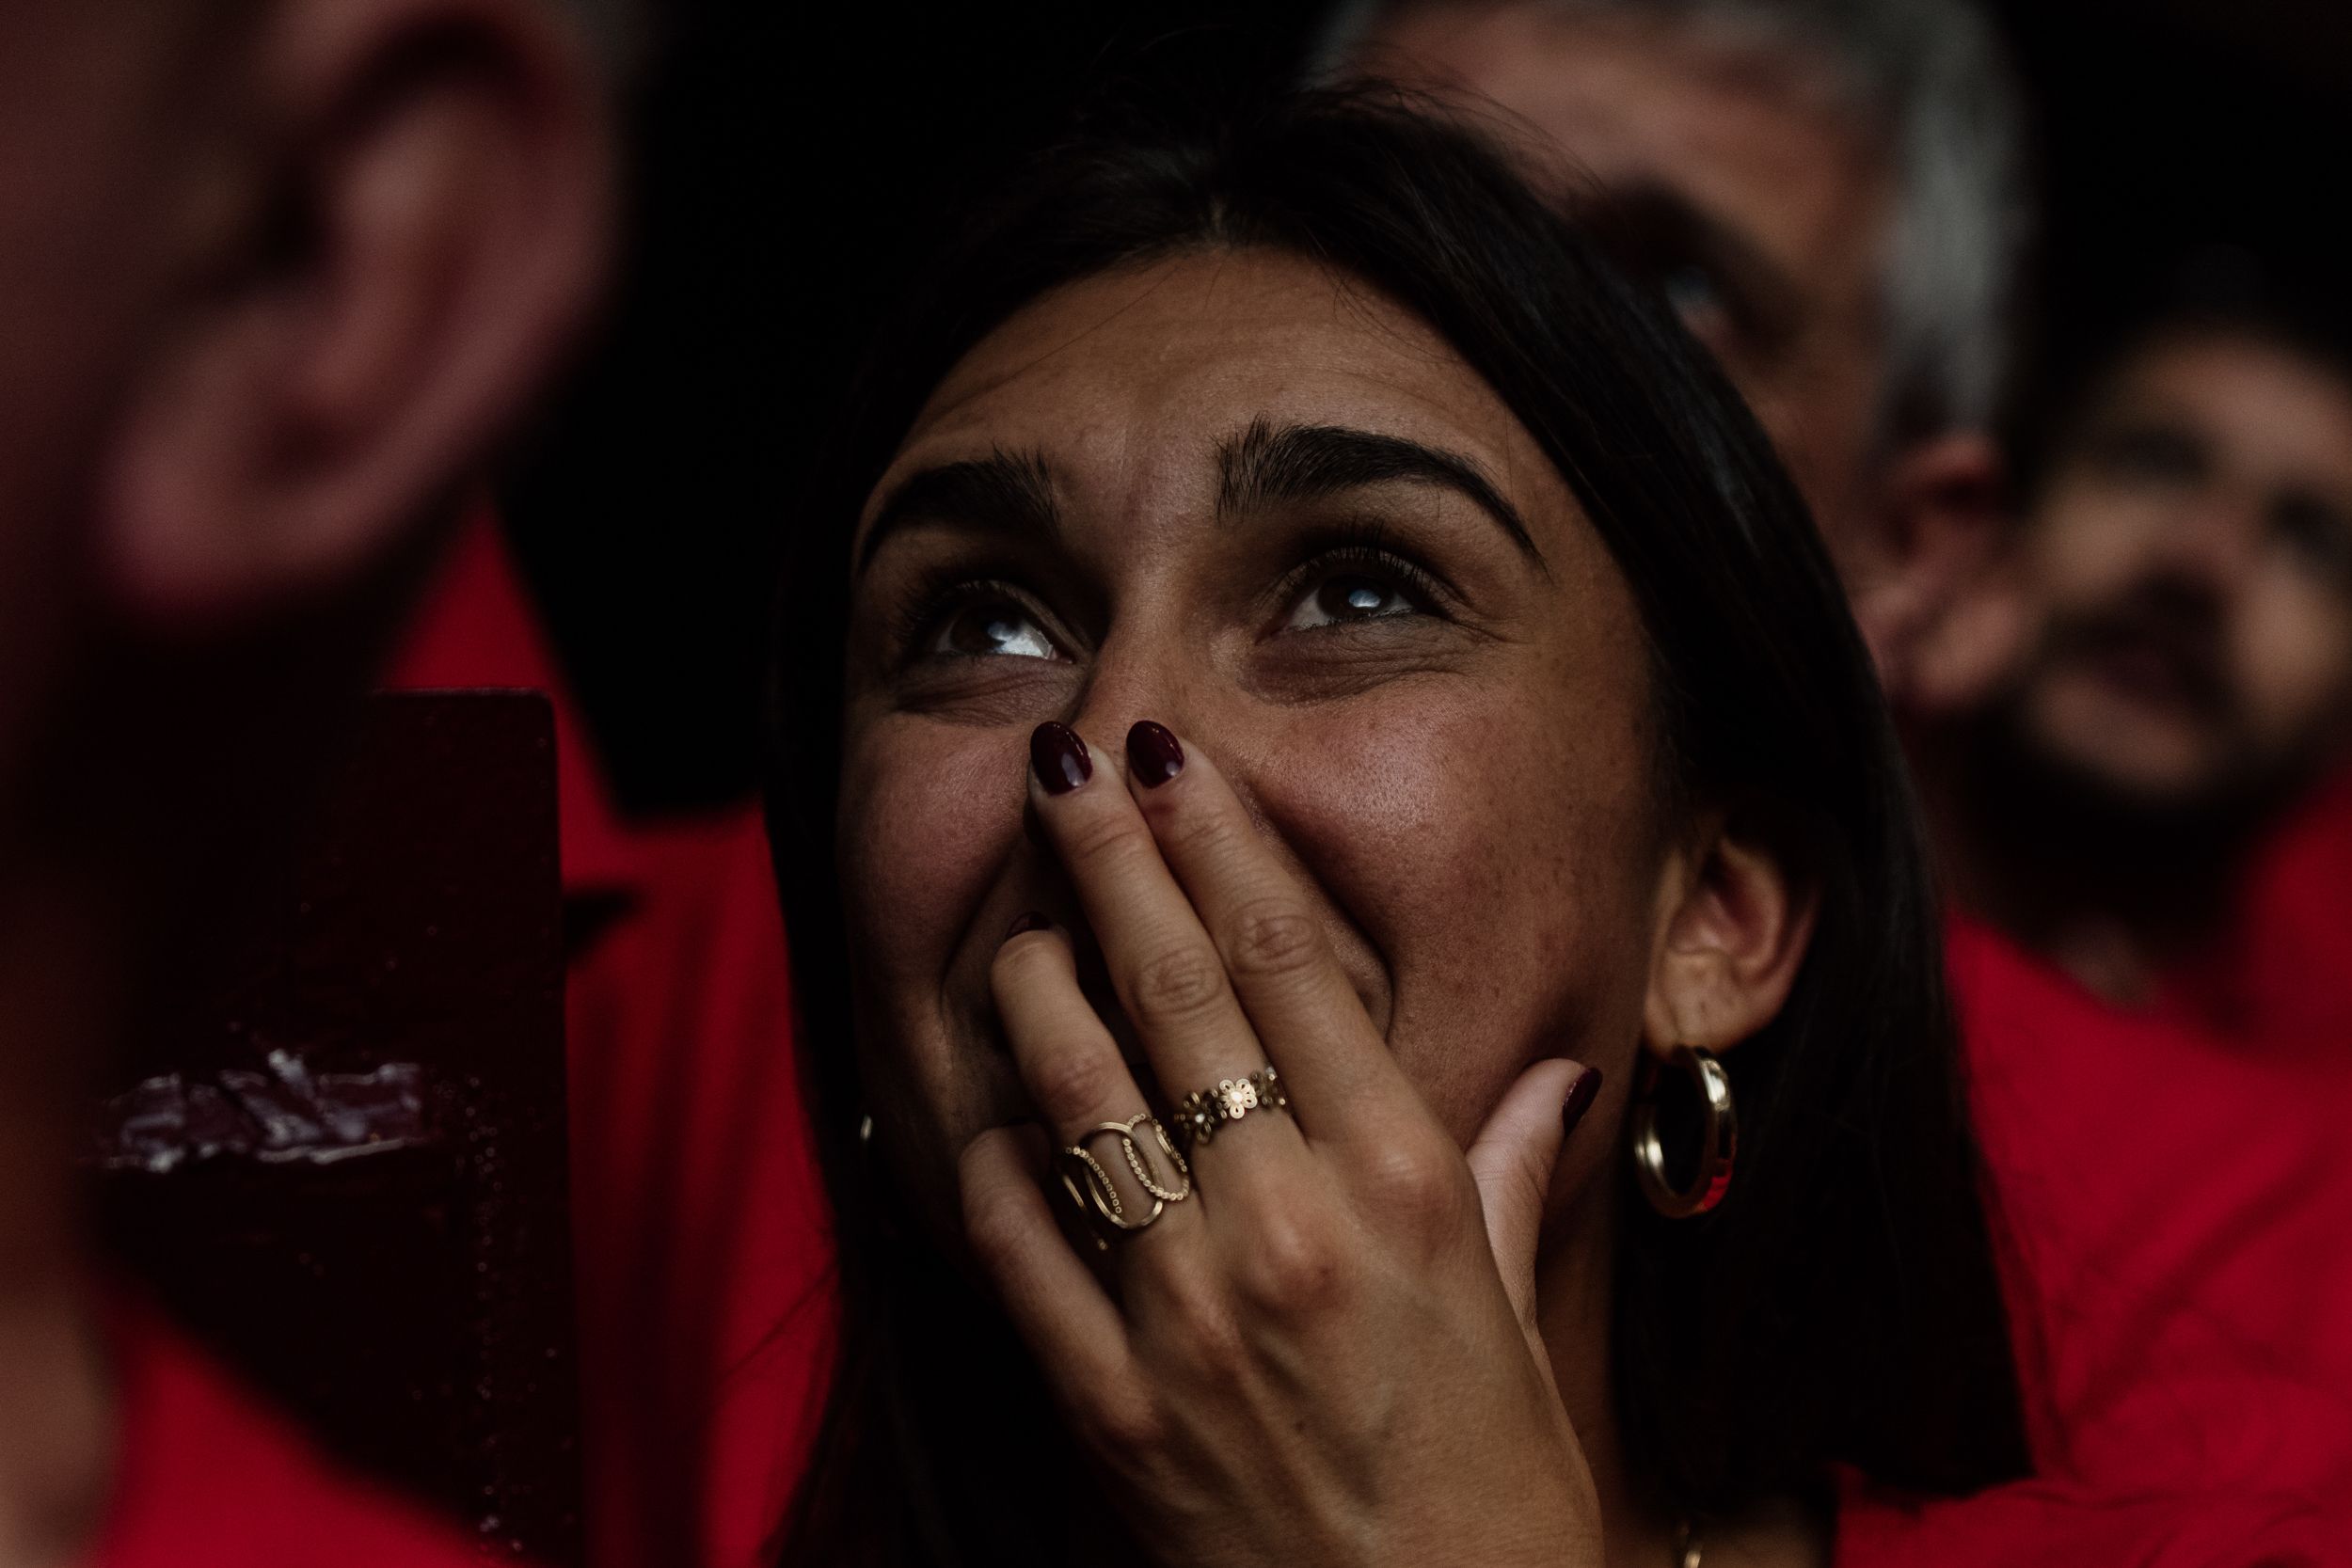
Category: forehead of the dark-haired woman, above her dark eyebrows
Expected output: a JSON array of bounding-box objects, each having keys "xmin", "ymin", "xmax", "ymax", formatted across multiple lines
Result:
[{"xmin": 878, "ymin": 249, "xmax": 1566, "ymax": 526}]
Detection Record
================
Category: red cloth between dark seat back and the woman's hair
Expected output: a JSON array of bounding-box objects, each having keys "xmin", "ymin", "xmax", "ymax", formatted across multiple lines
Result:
[{"xmin": 569, "ymin": 811, "xmax": 833, "ymax": 1568}]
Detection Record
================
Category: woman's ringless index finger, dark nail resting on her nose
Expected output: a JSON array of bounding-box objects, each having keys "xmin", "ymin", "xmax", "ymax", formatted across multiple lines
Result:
[{"xmin": 1127, "ymin": 720, "xmax": 1405, "ymax": 1138}]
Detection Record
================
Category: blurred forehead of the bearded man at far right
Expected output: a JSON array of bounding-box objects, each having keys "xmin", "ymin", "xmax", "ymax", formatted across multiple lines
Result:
[{"xmin": 2101, "ymin": 331, "xmax": 2352, "ymax": 489}]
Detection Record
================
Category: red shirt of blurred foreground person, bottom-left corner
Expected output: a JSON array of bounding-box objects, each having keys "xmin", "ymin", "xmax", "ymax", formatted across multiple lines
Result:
[{"xmin": 85, "ymin": 1309, "xmax": 483, "ymax": 1568}]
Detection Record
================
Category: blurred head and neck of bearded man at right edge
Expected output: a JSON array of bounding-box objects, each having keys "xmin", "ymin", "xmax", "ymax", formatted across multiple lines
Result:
[{"xmin": 1933, "ymin": 293, "xmax": 2352, "ymax": 1006}]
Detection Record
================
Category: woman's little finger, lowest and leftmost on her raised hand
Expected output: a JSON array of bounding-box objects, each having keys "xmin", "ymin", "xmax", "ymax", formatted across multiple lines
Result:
[{"xmin": 958, "ymin": 1126, "xmax": 1134, "ymax": 1403}]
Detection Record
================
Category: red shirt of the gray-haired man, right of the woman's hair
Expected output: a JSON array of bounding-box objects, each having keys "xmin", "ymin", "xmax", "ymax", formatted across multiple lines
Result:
[{"xmin": 1950, "ymin": 919, "xmax": 2352, "ymax": 1497}]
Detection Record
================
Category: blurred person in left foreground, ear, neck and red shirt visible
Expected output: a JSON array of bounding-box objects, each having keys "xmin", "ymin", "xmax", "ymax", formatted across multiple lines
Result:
[{"xmin": 0, "ymin": 0, "xmax": 607, "ymax": 1568}]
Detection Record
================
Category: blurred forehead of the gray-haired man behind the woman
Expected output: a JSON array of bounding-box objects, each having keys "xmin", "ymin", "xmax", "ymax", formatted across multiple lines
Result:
[{"xmin": 1362, "ymin": 5, "xmax": 1889, "ymax": 281}]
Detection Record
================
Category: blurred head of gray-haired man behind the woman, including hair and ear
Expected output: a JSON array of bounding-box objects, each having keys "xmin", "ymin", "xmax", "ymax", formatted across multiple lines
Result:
[{"xmin": 1320, "ymin": 0, "xmax": 2026, "ymax": 701}]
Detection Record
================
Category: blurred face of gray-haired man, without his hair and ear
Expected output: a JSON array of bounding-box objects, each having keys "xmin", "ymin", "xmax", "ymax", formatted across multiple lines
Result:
[{"xmin": 1355, "ymin": 0, "xmax": 1891, "ymax": 552}]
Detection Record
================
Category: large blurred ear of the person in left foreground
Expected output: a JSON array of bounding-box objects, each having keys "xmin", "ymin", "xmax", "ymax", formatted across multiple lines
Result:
[{"xmin": 99, "ymin": 0, "xmax": 610, "ymax": 623}]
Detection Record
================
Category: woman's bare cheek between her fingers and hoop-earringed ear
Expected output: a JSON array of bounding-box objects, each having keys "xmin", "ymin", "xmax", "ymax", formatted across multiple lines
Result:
[{"xmin": 1251, "ymin": 684, "xmax": 1651, "ymax": 1140}]
